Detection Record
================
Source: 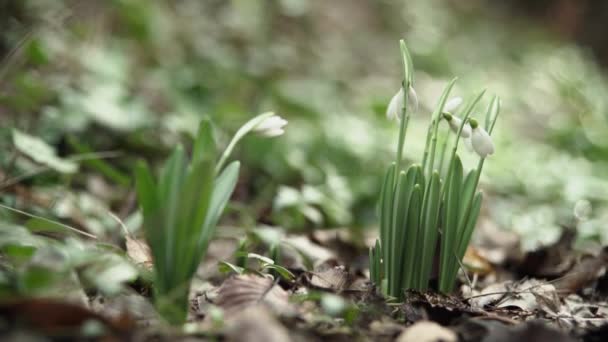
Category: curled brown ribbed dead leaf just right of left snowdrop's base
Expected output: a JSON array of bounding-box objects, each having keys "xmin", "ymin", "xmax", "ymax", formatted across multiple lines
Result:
[{"xmin": 215, "ymin": 274, "xmax": 292, "ymax": 317}]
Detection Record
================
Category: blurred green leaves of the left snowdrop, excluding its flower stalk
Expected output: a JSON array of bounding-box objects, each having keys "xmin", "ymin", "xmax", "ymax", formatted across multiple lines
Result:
[{"xmin": 136, "ymin": 121, "xmax": 239, "ymax": 324}]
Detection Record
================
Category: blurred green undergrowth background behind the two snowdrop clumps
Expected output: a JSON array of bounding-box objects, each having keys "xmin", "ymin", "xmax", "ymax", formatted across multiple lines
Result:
[{"xmin": 0, "ymin": 0, "xmax": 608, "ymax": 264}]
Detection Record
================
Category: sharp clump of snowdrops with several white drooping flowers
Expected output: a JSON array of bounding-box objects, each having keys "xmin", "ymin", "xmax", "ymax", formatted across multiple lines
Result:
[{"xmin": 369, "ymin": 41, "xmax": 500, "ymax": 299}]
